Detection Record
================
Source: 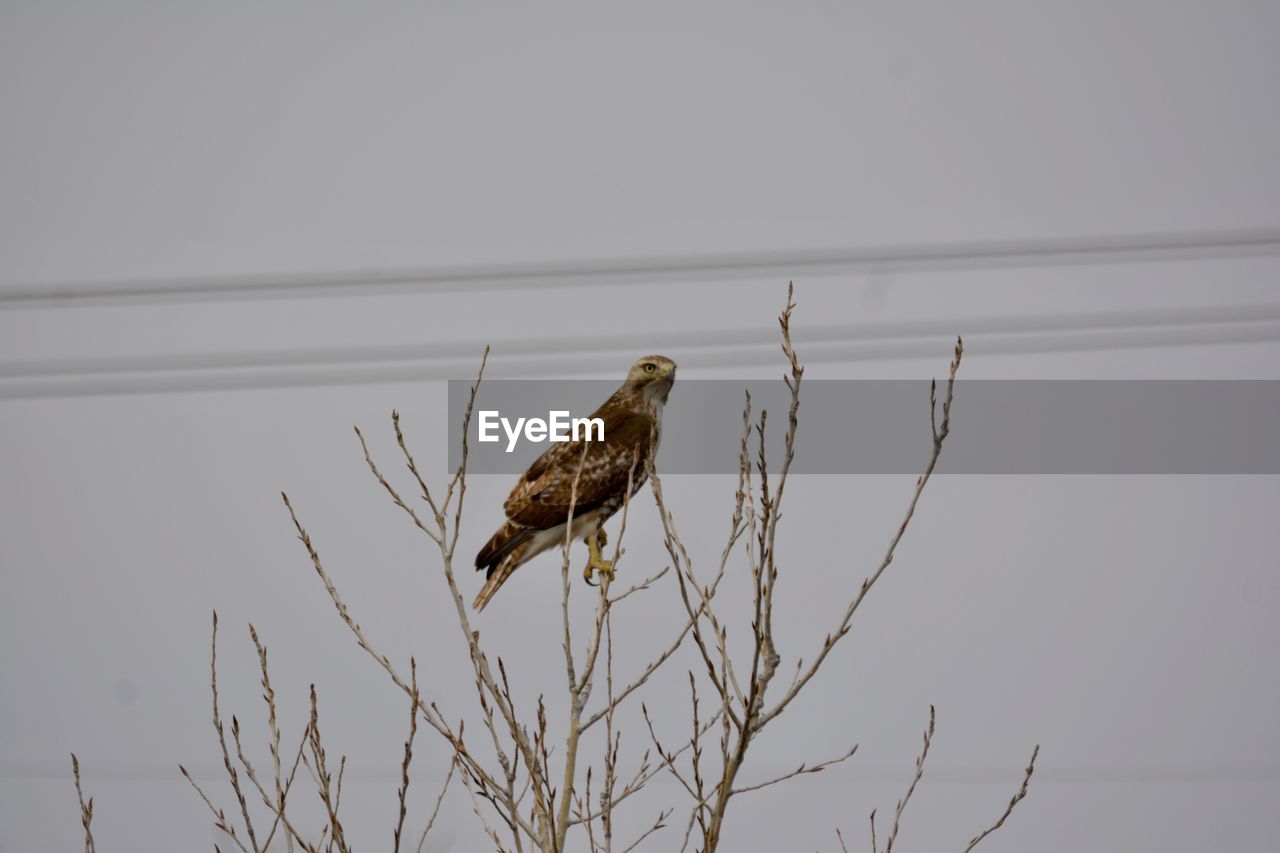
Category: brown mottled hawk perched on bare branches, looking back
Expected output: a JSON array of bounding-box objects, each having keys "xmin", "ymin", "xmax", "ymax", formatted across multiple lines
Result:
[{"xmin": 472, "ymin": 355, "xmax": 676, "ymax": 610}]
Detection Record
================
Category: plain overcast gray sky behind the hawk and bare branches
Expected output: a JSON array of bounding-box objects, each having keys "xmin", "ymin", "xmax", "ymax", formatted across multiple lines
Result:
[{"xmin": 0, "ymin": 3, "xmax": 1280, "ymax": 853}]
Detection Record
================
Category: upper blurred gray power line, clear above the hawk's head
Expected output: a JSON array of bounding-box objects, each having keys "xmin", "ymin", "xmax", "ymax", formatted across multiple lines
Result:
[{"xmin": 0, "ymin": 228, "xmax": 1280, "ymax": 310}]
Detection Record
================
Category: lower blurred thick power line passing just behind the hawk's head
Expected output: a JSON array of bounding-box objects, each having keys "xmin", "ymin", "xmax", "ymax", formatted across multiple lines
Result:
[{"xmin": 0, "ymin": 304, "xmax": 1280, "ymax": 400}]
